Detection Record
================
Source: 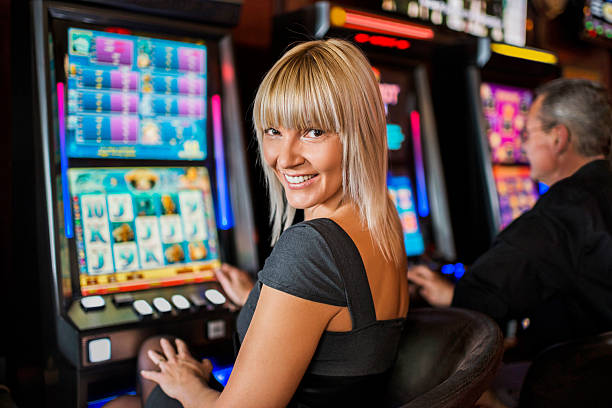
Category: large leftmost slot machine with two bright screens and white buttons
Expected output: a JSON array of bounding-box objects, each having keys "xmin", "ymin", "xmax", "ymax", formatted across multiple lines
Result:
[{"xmin": 31, "ymin": 1, "xmax": 259, "ymax": 407}]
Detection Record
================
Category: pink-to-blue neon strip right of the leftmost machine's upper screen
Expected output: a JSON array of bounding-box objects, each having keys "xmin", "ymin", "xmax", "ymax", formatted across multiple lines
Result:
[{"xmin": 210, "ymin": 95, "xmax": 234, "ymax": 230}]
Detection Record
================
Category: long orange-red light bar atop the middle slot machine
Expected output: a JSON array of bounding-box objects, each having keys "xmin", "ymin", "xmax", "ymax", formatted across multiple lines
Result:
[{"xmin": 343, "ymin": 9, "xmax": 434, "ymax": 40}]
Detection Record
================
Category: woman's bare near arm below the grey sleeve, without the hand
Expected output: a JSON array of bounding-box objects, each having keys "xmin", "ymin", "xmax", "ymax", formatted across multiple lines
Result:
[{"xmin": 214, "ymin": 285, "xmax": 342, "ymax": 408}]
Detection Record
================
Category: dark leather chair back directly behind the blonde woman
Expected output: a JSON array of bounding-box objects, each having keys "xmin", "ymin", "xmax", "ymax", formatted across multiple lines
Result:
[{"xmin": 386, "ymin": 308, "xmax": 503, "ymax": 408}]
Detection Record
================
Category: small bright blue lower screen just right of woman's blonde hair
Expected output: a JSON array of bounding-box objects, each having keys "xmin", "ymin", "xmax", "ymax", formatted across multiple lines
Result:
[{"xmin": 387, "ymin": 176, "xmax": 425, "ymax": 256}]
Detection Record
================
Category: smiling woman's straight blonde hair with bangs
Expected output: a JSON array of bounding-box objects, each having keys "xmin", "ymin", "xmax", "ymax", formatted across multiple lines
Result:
[{"xmin": 253, "ymin": 39, "xmax": 406, "ymax": 267}]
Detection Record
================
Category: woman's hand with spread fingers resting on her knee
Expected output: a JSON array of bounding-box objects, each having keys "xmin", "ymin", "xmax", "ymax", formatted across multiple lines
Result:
[{"xmin": 140, "ymin": 338, "xmax": 215, "ymax": 406}]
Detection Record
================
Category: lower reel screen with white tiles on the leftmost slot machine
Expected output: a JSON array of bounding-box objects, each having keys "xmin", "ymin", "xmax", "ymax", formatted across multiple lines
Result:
[{"xmin": 68, "ymin": 167, "xmax": 220, "ymax": 296}]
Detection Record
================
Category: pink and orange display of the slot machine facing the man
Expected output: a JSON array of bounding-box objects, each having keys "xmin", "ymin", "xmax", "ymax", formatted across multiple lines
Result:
[{"xmin": 480, "ymin": 83, "xmax": 539, "ymax": 229}]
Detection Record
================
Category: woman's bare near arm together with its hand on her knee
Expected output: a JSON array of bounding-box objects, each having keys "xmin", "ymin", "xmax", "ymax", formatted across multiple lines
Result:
[{"xmin": 143, "ymin": 285, "xmax": 342, "ymax": 408}]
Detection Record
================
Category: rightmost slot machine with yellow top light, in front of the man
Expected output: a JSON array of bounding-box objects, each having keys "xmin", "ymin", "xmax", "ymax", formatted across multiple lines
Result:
[{"xmin": 434, "ymin": 38, "xmax": 560, "ymax": 263}]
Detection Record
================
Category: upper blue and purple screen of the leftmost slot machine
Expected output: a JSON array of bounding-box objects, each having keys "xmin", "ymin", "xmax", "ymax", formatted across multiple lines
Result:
[{"xmin": 66, "ymin": 28, "xmax": 206, "ymax": 160}]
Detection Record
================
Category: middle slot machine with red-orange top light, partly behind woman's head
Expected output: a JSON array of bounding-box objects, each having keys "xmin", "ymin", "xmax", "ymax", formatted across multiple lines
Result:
[{"xmin": 273, "ymin": 2, "xmax": 456, "ymax": 264}]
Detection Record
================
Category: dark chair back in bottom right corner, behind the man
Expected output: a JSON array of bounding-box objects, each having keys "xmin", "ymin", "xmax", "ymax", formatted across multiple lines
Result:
[{"xmin": 519, "ymin": 332, "xmax": 612, "ymax": 408}]
